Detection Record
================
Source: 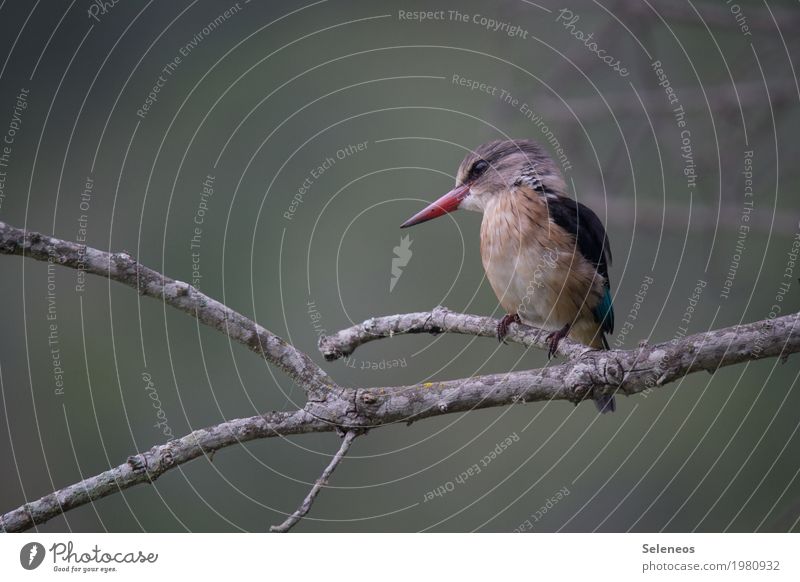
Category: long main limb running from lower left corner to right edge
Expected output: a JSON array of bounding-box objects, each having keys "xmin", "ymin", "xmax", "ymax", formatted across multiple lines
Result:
[{"xmin": 6, "ymin": 312, "xmax": 800, "ymax": 531}]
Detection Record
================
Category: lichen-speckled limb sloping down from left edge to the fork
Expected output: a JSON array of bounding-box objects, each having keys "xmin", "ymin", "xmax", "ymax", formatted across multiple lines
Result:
[{"xmin": 0, "ymin": 222, "xmax": 336, "ymax": 400}]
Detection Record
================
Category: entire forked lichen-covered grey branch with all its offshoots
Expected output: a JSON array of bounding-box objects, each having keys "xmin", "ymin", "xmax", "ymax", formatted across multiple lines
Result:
[{"xmin": 0, "ymin": 222, "xmax": 800, "ymax": 532}]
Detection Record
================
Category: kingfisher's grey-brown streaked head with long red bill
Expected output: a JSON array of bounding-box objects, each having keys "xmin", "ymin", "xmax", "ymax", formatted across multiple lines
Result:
[{"xmin": 400, "ymin": 139, "xmax": 566, "ymax": 228}]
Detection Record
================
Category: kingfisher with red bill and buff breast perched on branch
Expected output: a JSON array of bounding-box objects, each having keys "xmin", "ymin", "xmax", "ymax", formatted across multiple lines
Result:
[{"xmin": 400, "ymin": 139, "xmax": 616, "ymax": 412}]
